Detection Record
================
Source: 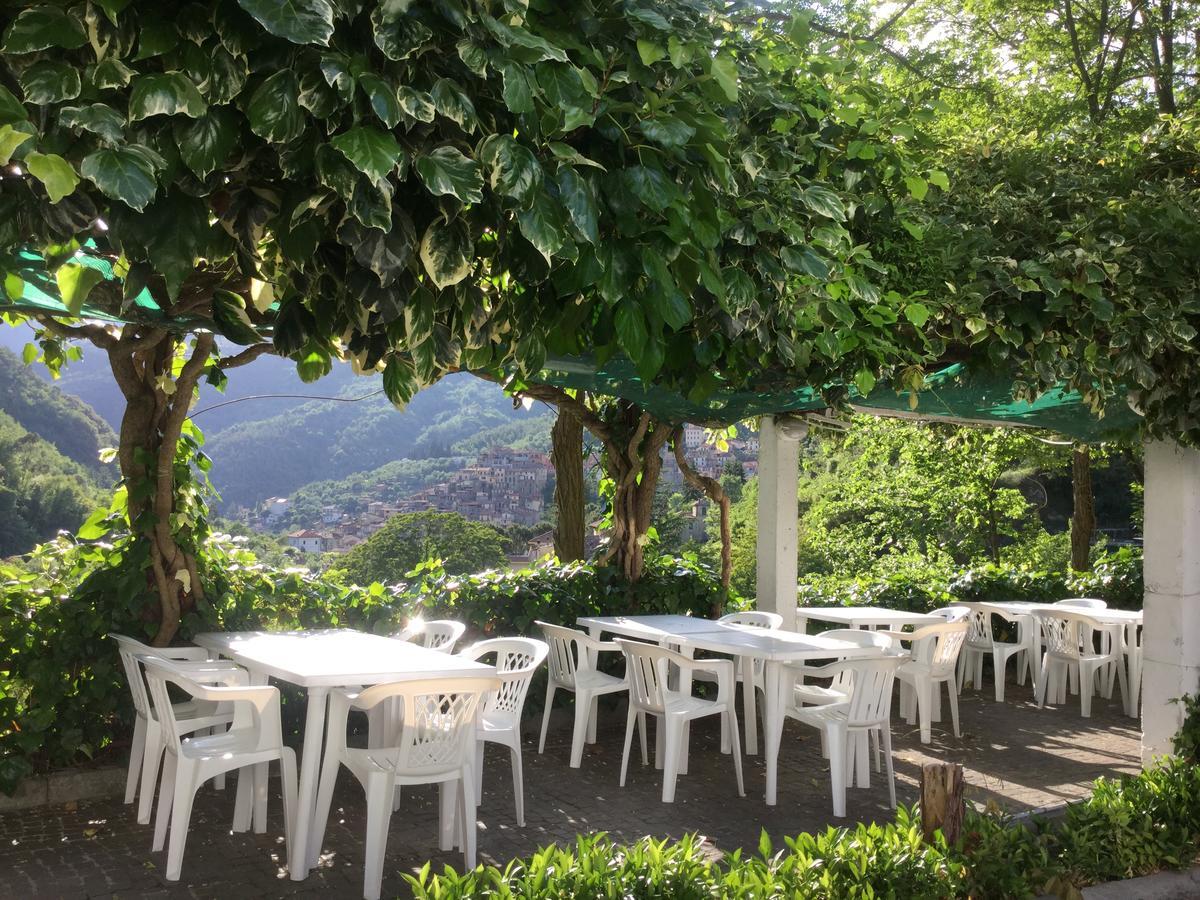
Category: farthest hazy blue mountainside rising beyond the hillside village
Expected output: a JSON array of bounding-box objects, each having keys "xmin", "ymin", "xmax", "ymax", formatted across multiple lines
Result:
[{"xmin": 0, "ymin": 328, "xmax": 550, "ymax": 511}]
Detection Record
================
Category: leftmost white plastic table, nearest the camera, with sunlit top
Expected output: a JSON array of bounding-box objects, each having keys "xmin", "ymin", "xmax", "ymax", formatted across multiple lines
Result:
[{"xmin": 196, "ymin": 630, "xmax": 496, "ymax": 881}]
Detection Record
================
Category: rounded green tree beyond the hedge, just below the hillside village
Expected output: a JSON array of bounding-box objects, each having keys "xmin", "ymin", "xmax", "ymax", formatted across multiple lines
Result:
[{"xmin": 332, "ymin": 511, "xmax": 508, "ymax": 584}]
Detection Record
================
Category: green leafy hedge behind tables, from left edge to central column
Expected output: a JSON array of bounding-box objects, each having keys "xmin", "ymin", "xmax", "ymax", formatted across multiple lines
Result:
[{"xmin": 0, "ymin": 535, "xmax": 720, "ymax": 792}]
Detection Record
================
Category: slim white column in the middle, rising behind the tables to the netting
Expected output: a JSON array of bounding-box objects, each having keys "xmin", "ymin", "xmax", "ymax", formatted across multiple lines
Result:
[{"xmin": 757, "ymin": 415, "xmax": 800, "ymax": 631}]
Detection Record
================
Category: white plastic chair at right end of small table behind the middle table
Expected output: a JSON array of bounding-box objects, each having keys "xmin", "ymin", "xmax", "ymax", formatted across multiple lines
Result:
[{"xmin": 883, "ymin": 622, "xmax": 968, "ymax": 744}]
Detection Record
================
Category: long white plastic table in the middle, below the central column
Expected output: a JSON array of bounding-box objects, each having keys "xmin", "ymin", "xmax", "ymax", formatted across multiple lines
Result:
[{"xmin": 577, "ymin": 616, "xmax": 878, "ymax": 806}]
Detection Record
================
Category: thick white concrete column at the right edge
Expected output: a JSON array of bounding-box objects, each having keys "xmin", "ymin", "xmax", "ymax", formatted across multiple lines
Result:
[{"xmin": 1141, "ymin": 440, "xmax": 1200, "ymax": 764}]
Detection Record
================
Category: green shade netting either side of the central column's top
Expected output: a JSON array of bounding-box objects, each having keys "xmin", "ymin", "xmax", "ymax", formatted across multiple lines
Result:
[{"xmin": 538, "ymin": 359, "xmax": 1140, "ymax": 443}]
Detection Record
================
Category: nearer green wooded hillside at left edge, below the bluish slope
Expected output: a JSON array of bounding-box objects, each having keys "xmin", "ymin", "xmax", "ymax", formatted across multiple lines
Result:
[{"xmin": 0, "ymin": 410, "xmax": 107, "ymax": 557}]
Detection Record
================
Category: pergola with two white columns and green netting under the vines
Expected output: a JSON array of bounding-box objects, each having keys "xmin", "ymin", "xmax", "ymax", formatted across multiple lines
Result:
[{"xmin": 9, "ymin": 252, "xmax": 1200, "ymax": 764}]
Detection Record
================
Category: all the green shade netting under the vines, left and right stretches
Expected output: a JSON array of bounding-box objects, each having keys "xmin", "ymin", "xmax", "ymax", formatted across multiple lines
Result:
[{"xmin": 0, "ymin": 242, "xmax": 1140, "ymax": 443}]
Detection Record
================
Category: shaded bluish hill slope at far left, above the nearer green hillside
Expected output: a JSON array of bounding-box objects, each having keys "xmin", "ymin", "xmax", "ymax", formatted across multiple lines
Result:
[{"xmin": 0, "ymin": 348, "xmax": 119, "ymax": 486}]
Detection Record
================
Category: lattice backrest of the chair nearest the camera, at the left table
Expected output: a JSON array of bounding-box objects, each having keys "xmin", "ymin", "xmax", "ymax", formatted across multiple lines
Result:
[{"xmin": 354, "ymin": 676, "xmax": 500, "ymax": 776}]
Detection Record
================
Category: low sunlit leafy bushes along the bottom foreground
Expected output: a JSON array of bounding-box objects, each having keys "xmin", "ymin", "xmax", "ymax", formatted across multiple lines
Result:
[{"xmin": 406, "ymin": 760, "xmax": 1200, "ymax": 900}]
